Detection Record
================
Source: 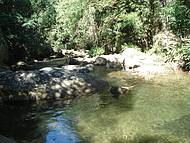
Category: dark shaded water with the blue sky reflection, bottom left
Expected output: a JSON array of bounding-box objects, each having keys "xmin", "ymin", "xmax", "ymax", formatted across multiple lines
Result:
[{"xmin": 0, "ymin": 103, "xmax": 82, "ymax": 143}]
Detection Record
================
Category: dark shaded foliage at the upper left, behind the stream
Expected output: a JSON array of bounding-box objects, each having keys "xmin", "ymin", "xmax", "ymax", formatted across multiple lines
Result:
[{"xmin": 0, "ymin": 0, "xmax": 53, "ymax": 65}]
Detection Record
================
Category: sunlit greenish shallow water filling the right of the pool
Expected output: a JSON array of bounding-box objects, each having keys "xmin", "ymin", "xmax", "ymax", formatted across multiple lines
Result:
[{"xmin": 67, "ymin": 72, "xmax": 190, "ymax": 143}]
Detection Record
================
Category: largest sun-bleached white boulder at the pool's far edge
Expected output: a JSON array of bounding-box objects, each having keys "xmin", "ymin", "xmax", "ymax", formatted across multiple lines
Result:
[{"xmin": 122, "ymin": 48, "xmax": 170, "ymax": 75}]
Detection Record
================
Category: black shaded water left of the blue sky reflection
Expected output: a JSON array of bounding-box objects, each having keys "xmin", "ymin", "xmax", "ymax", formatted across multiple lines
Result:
[{"xmin": 0, "ymin": 104, "xmax": 42, "ymax": 140}]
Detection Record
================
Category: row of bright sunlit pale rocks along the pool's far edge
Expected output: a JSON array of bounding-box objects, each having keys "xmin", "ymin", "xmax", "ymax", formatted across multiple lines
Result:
[{"xmin": 95, "ymin": 48, "xmax": 182, "ymax": 76}]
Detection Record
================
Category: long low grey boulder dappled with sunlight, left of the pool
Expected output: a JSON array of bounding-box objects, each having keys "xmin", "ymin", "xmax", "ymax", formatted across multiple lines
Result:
[{"xmin": 0, "ymin": 66, "xmax": 108, "ymax": 101}]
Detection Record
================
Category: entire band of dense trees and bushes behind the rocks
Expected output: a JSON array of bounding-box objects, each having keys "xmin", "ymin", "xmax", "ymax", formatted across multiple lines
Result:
[{"xmin": 0, "ymin": 0, "xmax": 190, "ymax": 68}]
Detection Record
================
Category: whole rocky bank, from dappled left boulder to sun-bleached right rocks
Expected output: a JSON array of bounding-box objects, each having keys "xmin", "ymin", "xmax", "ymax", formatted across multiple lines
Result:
[{"xmin": 0, "ymin": 48, "xmax": 184, "ymax": 102}]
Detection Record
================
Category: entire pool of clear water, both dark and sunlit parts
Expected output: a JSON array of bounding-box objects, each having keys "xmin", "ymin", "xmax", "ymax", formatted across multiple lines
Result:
[{"xmin": 0, "ymin": 70, "xmax": 190, "ymax": 143}]
